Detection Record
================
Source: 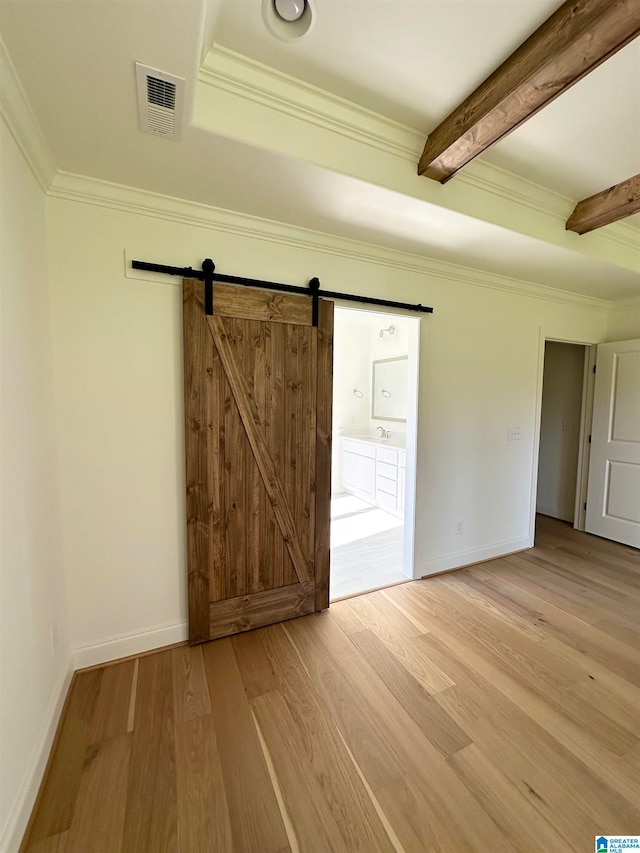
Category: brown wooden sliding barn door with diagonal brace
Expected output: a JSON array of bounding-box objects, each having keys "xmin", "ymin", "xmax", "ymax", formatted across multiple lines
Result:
[{"xmin": 183, "ymin": 279, "xmax": 333, "ymax": 643}]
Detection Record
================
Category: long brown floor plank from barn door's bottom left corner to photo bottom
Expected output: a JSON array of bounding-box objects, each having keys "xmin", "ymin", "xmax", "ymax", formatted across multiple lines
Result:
[{"xmin": 202, "ymin": 640, "xmax": 288, "ymax": 853}]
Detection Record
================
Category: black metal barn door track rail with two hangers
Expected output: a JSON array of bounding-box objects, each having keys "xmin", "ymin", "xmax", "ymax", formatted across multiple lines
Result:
[{"xmin": 131, "ymin": 258, "xmax": 433, "ymax": 326}]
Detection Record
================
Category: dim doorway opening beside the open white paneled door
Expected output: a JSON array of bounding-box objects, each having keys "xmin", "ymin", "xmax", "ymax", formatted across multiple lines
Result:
[{"xmin": 536, "ymin": 340, "xmax": 596, "ymax": 544}]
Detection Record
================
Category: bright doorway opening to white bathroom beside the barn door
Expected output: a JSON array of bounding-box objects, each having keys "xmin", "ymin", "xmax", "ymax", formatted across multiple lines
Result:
[{"xmin": 329, "ymin": 307, "xmax": 420, "ymax": 600}]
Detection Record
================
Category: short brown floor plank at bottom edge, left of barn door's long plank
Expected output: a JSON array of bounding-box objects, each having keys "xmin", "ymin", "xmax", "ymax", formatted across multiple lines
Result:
[{"xmin": 176, "ymin": 715, "xmax": 234, "ymax": 853}]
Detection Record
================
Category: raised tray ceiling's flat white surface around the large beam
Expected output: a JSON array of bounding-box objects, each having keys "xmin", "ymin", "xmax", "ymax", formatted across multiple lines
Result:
[{"xmin": 215, "ymin": 0, "xmax": 640, "ymax": 201}]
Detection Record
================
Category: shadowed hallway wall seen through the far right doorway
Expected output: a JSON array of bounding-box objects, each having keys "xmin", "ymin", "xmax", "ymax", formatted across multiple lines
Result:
[{"xmin": 537, "ymin": 341, "xmax": 585, "ymax": 522}]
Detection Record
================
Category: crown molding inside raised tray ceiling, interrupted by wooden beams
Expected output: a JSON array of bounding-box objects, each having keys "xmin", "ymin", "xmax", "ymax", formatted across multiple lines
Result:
[{"xmin": 198, "ymin": 44, "xmax": 640, "ymax": 251}]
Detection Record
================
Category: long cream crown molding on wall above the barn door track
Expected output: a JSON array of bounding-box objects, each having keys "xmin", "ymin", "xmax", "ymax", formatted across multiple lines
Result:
[{"xmin": 49, "ymin": 172, "xmax": 615, "ymax": 311}]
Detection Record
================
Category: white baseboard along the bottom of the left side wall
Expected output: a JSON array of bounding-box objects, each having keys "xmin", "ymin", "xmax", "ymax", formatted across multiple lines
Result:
[{"xmin": 0, "ymin": 659, "xmax": 73, "ymax": 853}]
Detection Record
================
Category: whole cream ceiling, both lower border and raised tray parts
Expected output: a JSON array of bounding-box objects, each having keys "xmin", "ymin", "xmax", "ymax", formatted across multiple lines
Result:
[{"xmin": 0, "ymin": 0, "xmax": 640, "ymax": 299}]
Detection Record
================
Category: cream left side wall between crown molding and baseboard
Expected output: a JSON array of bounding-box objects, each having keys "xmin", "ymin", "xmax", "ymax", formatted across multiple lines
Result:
[{"xmin": 0, "ymin": 119, "xmax": 71, "ymax": 853}]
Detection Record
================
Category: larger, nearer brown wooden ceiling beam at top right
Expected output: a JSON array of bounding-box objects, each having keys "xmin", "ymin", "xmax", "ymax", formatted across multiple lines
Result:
[{"xmin": 418, "ymin": 0, "xmax": 640, "ymax": 183}]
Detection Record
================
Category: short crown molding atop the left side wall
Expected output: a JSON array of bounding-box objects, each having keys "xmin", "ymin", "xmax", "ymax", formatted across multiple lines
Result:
[{"xmin": 0, "ymin": 38, "xmax": 56, "ymax": 192}]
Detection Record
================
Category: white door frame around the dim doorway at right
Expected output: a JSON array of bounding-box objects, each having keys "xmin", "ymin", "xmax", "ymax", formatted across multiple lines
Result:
[{"xmin": 529, "ymin": 328, "xmax": 597, "ymax": 548}]
